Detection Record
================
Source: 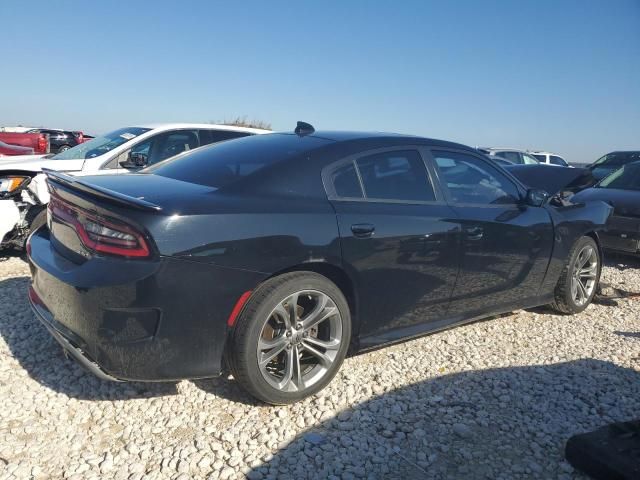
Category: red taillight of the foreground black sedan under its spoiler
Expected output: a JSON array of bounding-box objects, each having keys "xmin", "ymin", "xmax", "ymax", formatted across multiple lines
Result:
[{"xmin": 48, "ymin": 197, "xmax": 151, "ymax": 258}]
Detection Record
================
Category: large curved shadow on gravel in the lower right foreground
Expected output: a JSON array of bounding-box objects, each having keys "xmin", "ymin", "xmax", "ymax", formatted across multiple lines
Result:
[{"xmin": 249, "ymin": 359, "xmax": 640, "ymax": 479}]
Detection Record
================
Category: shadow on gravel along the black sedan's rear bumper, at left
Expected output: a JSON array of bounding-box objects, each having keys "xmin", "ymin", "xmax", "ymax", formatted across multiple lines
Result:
[{"xmin": 0, "ymin": 277, "xmax": 177, "ymax": 400}]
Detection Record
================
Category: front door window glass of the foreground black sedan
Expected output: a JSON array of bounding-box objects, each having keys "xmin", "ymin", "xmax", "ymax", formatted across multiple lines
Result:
[{"xmin": 432, "ymin": 151, "xmax": 520, "ymax": 205}]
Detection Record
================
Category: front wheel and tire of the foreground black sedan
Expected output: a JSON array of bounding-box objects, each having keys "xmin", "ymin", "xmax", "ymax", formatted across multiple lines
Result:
[{"xmin": 551, "ymin": 236, "xmax": 602, "ymax": 314}]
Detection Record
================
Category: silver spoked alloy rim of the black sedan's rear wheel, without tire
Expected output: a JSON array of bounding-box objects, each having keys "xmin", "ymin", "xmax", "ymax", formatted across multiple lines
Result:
[{"xmin": 258, "ymin": 290, "xmax": 342, "ymax": 392}]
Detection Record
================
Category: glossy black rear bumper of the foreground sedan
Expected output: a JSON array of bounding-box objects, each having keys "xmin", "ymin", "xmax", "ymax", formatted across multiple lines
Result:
[{"xmin": 29, "ymin": 229, "xmax": 264, "ymax": 381}]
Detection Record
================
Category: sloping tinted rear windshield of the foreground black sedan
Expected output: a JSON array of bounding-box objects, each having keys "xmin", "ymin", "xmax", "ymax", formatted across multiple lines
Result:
[{"xmin": 142, "ymin": 134, "xmax": 330, "ymax": 188}]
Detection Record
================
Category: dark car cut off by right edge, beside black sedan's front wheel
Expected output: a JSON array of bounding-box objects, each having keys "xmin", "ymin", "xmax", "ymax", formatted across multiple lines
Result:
[{"xmin": 572, "ymin": 162, "xmax": 640, "ymax": 255}]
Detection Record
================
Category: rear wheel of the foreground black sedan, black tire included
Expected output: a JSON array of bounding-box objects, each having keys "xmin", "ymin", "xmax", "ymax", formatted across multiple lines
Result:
[{"xmin": 228, "ymin": 272, "xmax": 351, "ymax": 405}]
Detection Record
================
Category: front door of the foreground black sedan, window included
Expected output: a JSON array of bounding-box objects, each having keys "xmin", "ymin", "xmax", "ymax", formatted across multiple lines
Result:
[{"xmin": 431, "ymin": 149, "xmax": 553, "ymax": 318}]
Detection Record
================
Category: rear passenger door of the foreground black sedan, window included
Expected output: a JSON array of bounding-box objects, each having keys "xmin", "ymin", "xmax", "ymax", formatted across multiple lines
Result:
[{"xmin": 324, "ymin": 146, "xmax": 460, "ymax": 347}]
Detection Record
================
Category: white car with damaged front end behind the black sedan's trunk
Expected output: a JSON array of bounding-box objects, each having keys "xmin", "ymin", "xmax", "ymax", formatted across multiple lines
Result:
[{"xmin": 0, "ymin": 123, "xmax": 271, "ymax": 248}]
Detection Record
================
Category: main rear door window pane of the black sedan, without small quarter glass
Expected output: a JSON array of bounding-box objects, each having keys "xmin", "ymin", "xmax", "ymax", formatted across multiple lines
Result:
[{"xmin": 355, "ymin": 150, "xmax": 436, "ymax": 202}]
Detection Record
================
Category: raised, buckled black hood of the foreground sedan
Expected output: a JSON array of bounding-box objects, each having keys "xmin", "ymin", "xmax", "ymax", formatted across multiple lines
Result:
[{"xmin": 504, "ymin": 165, "xmax": 596, "ymax": 195}]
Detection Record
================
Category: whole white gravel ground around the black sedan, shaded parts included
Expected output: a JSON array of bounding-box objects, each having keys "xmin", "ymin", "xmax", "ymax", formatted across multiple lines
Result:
[{"xmin": 0, "ymin": 253, "xmax": 640, "ymax": 480}]
